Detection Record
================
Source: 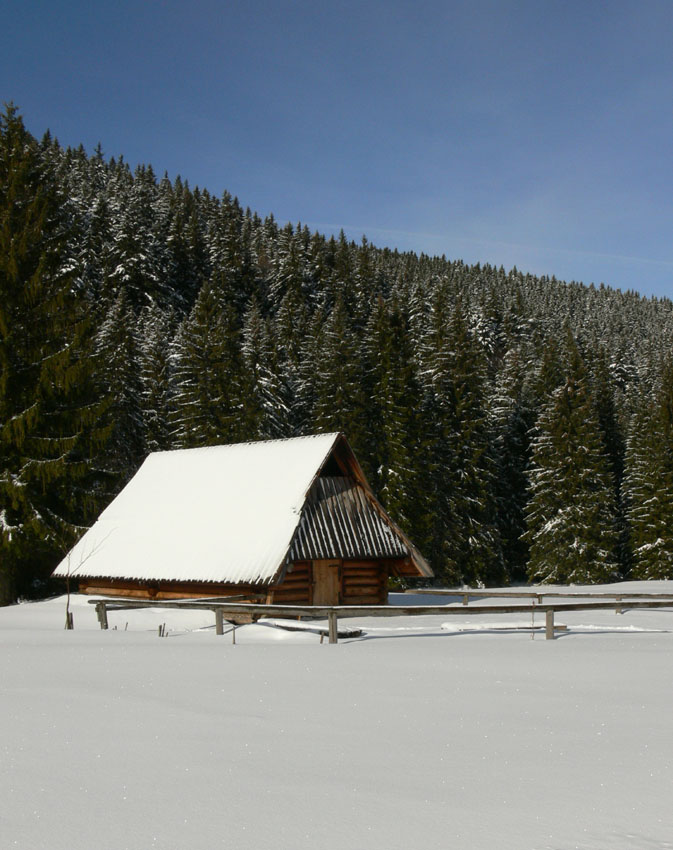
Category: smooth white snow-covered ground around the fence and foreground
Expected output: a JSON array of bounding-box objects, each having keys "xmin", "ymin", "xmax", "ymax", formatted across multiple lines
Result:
[{"xmin": 0, "ymin": 582, "xmax": 673, "ymax": 850}]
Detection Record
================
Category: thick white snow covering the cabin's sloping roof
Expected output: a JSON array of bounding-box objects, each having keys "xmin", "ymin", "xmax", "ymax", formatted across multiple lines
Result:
[{"xmin": 54, "ymin": 434, "xmax": 338, "ymax": 583}]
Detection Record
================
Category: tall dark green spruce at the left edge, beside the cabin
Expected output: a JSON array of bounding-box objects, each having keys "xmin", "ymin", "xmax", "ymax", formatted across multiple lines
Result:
[{"xmin": 0, "ymin": 105, "xmax": 105, "ymax": 604}]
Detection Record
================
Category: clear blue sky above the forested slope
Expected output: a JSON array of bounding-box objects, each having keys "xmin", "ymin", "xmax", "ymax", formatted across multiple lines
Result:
[{"xmin": 5, "ymin": 0, "xmax": 673, "ymax": 297}]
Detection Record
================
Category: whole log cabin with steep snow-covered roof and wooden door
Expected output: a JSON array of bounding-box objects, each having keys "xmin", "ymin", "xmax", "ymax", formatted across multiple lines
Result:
[{"xmin": 54, "ymin": 434, "xmax": 432, "ymax": 605}]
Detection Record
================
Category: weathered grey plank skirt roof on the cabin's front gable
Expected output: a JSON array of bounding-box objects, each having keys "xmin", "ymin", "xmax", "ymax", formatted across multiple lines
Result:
[{"xmin": 289, "ymin": 476, "xmax": 410, "ymax": 561}]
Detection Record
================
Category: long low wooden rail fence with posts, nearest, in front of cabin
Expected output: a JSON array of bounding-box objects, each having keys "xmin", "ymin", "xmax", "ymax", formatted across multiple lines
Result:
[{"xmin": 89, "ymin": 596, "xmax": 673, "ymax": 643}]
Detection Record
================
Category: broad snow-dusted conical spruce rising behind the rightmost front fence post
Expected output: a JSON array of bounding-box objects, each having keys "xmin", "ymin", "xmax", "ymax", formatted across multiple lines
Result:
[{"xmin": 526, "ymin": 340, "xmax": 619, "ymax": 584}]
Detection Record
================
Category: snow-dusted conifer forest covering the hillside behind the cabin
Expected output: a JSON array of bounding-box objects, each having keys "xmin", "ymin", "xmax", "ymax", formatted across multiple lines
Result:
[{"xmin": 0, "ymin": 106, "xmax": 673, "ymax": 604}]
